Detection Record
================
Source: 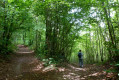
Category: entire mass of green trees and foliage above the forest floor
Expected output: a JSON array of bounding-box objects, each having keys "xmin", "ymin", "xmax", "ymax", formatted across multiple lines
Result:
[{"xmin": 0, "ymin": 0, "xmax": 119, "ymax": 67}]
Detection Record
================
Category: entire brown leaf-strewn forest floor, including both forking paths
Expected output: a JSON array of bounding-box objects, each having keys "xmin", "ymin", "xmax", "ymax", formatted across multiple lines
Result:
[{"xmin": 0, "ymin": 45, "xmax": 115, "ymax": 80}]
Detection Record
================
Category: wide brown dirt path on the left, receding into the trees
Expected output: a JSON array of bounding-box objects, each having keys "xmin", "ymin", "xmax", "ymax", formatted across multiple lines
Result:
[{"xmin": 0, "ymin": 45, "xmax": 62, "ymax": 80}]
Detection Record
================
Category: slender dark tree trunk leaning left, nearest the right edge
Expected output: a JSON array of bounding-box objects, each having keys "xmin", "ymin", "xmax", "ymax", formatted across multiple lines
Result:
[{"xmin": 102, "ymin": 0, "xmax": 118, "ymax": 59}]
